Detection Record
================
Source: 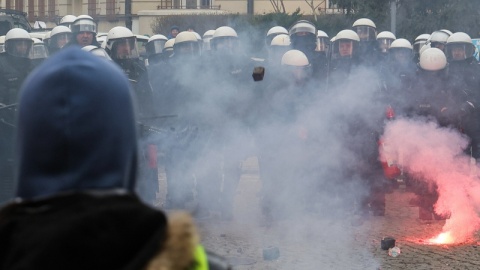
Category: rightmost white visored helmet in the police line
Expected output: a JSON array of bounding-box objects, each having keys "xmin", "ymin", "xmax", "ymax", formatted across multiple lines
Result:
[{"xmin": 445, "ymin": 32, "xmax": 475, "ymax": 61}]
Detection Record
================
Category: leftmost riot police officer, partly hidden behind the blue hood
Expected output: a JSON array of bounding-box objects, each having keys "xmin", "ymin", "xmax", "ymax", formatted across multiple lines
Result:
[{"xmin": 0, "ymin": 28, "xmax": 33, "ymax": 203}]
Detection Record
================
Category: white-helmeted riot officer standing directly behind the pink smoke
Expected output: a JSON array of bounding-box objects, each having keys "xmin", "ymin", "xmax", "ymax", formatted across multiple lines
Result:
[{"xmin": 407, "ymin": 48, "xmax": 480, "ymax": 220}]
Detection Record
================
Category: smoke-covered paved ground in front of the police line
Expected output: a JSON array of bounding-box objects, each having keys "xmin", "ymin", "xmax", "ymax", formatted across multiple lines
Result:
[{"xmin": 159, "ymin": 158, "xmax": 480, "ymax": 270}]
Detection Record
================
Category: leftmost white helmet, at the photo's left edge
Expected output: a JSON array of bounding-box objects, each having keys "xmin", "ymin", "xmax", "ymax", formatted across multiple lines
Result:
[{"xmin": 5, "ymin": 28, "xmax": 33, "ymax": 58}]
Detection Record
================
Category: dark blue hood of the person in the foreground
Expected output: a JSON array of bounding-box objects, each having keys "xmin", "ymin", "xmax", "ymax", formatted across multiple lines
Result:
[{"xmin": 16, "ymin": 47, "xmax": 137, "ymax": 199}]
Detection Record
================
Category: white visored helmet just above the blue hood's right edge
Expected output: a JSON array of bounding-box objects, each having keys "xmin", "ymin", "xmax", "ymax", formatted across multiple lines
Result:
[{"xmin": 106, "ymin": 26, "xmax": 139, "ymax": 61}]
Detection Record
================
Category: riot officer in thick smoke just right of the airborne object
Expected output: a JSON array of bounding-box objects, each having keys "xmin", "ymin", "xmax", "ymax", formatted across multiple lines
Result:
[{"xmin": 256, "ymin": 50, "xmax": 318, "ymax": 222}]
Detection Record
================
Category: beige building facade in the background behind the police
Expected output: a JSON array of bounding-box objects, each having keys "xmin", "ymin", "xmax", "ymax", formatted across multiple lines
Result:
[{"xmin": 0, "ymin": 0, "xmax": 344, "ymax": 34}]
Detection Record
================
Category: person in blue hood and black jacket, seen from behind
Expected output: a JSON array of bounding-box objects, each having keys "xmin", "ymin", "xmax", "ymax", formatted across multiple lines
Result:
[{"xmin": 0, "ymin": 48, "xmax": 228, "ymax": 270}]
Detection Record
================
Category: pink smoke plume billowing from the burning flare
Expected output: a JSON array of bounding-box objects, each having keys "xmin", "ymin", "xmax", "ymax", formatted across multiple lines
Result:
[{"xmin": 380, "ymin": 118, "xmax": 480, "ymax": 243}]
